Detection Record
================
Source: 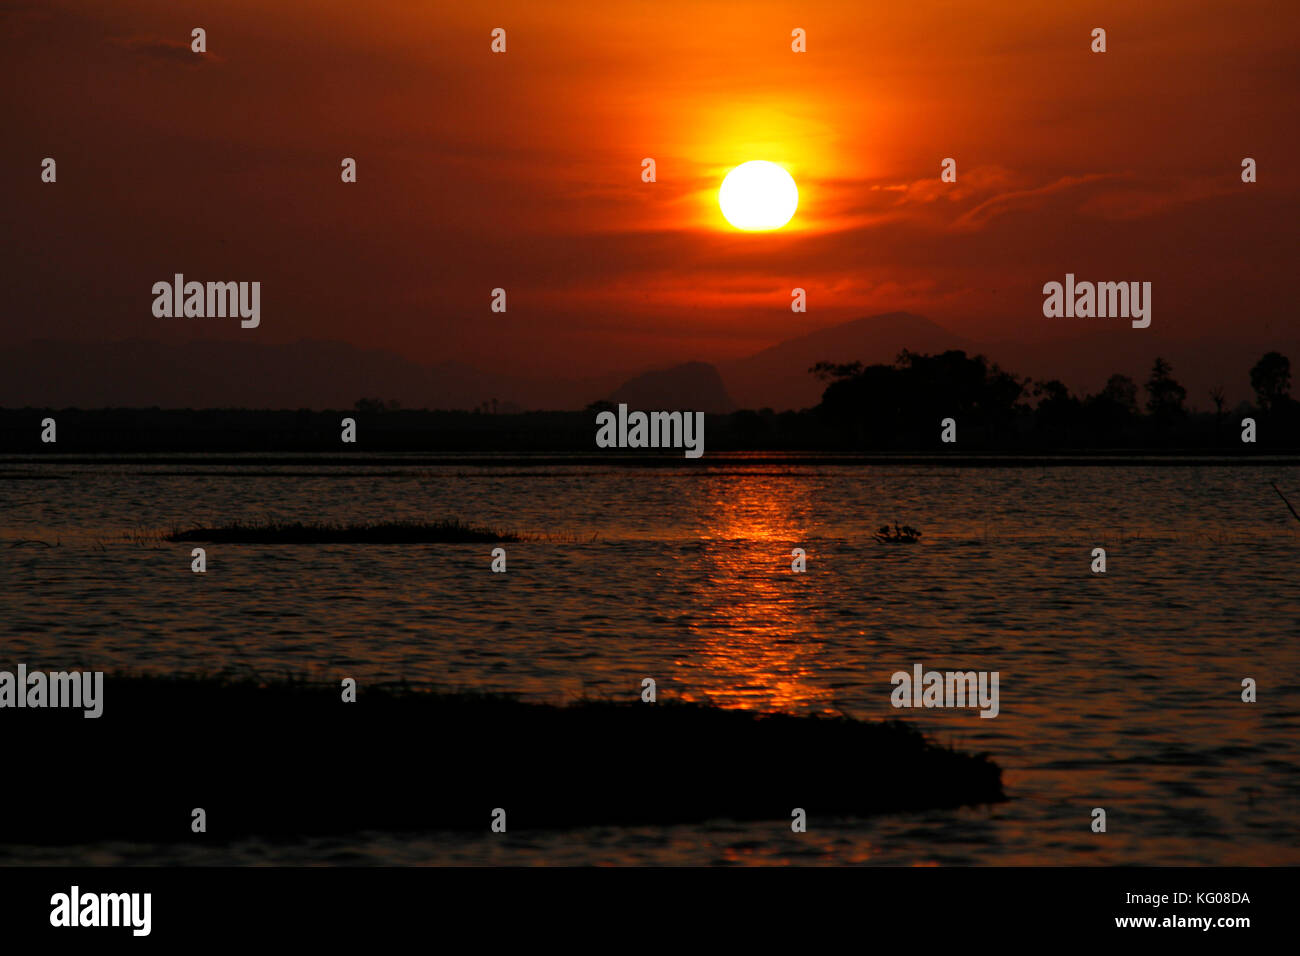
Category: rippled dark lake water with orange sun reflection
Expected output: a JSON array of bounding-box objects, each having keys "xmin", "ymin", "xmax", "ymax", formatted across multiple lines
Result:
[{"xmin": 0, "ymin": 455, "xmax": 1300, "ymax": 865}]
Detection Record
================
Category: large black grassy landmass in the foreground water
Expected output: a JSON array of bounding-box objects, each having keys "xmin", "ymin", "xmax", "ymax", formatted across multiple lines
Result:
[{"xmin": 0, "ymin": 665, "xmax": 1006, "ymax": 844}]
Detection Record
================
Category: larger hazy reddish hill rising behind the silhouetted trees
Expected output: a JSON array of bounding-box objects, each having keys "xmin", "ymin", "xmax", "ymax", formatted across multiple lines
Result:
[{"xmin": 718, "ymin": 312, "xmax": 971, "ymax": 411}]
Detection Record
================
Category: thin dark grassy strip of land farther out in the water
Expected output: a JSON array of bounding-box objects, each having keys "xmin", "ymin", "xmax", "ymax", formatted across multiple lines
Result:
[{"xmin": 164, "ymin": 522, "xmax": 520, "ymax": 545}]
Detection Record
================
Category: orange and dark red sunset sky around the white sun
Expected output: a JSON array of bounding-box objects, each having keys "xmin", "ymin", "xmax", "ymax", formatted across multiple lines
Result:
[{"xmin": 0, "ymin": 0, "xmax": 1300, "ymax": 373}]
